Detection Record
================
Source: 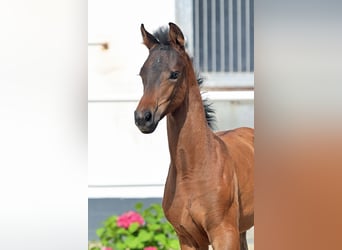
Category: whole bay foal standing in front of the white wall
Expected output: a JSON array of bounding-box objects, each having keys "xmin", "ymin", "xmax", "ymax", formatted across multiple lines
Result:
[{"xmin": 134, "ymin": 23, "xmax": 254, "ymax": 250}]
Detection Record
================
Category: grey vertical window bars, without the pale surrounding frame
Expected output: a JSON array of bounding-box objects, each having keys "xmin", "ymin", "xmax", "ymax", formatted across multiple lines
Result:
[{"xmin": 193, "ymin": 0, "xmax": 254, "ymax": 72}]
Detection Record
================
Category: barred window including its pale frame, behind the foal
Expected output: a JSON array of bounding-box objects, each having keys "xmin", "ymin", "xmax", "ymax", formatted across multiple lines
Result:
[{"xmin": 176, "ymin": 0, "xmax": 254, "ymax": 89}]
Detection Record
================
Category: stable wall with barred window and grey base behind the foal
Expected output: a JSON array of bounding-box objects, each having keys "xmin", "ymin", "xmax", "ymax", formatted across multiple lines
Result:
[{"xmin": 88, "ymin": 0, "xmax": 254, "ymax": 246}]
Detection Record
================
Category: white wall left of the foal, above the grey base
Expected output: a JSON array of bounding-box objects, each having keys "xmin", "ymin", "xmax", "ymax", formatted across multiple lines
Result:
[{"xmin": 88, "ymin": 0, "xmax": 175, "ymax": 197}]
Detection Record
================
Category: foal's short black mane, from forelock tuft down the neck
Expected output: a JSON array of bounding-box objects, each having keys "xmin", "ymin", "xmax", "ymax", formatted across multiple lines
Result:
[{"xmin": 153, "ymin": 26, "xmax": 216, "ymax": 130}]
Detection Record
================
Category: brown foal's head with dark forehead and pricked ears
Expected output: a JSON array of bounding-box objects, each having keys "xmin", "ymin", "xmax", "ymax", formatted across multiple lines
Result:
[{"xmin": 134, "ymin": 23, "xmax": 192, "ymax": 133}]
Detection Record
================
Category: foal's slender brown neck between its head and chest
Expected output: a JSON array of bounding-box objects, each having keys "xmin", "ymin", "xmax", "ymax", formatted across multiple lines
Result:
[{"xmin": 167, "ymin": 73, "xmax": 212, "ymax": 173}]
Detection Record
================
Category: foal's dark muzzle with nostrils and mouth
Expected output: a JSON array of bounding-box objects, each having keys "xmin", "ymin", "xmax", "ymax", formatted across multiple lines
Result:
[{"xmin": 134, "ymin": 110, "xmax": 159, "ymax": 134}]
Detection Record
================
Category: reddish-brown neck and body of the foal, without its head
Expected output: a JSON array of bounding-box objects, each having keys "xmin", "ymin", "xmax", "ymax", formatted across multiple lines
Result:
[{"xmin": 163, "ymin": 79, "xmax": 254, "ymax": 249}]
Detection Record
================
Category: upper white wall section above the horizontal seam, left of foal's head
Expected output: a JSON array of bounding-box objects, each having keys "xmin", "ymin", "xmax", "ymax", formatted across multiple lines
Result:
[{"xmin": 88, "ymin": 0, "xmax": 175, "ymax": 100}]
